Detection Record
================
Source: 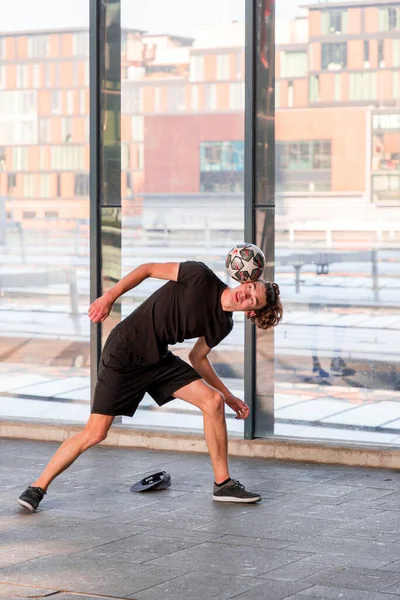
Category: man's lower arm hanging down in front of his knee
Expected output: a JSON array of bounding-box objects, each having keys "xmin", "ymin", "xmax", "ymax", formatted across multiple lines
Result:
[{"xmin": 189, "ymin": 337, "xmax": 250, "ymax": 419}]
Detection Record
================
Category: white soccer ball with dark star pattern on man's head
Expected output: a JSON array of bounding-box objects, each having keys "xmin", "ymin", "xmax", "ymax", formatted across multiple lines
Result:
[{"xmin": 225, "ymin": 244, "xmax": 265, "ymax": 283}]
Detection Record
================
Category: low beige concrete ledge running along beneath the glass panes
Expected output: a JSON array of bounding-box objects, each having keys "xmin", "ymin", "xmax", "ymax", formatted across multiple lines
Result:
[{"xmin": 0, "ymin": 420, "xmax": 400, "ymax": 469}]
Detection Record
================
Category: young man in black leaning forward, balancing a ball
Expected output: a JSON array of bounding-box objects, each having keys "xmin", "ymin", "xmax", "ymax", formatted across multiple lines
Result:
[{"xmin": 18, "ymin": 261, "xmax": 282, "ymax": 512}]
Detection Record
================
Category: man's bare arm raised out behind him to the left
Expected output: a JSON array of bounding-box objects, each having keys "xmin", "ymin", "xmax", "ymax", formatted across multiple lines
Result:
[{"xmin": 88, "ymin": 263, "xmax": 180, "ymax": 323}]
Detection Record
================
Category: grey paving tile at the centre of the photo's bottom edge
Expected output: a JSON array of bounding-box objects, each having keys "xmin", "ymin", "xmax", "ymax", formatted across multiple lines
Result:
[{"xmin": 134, "ymin": 572, "xmax": 260, "ymax": 600}]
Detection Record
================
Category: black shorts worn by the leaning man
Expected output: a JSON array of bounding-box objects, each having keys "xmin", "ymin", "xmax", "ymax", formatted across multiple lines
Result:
[{"xmin": 91, "ymin": 332, "xmax": 201, "ymax": 417}]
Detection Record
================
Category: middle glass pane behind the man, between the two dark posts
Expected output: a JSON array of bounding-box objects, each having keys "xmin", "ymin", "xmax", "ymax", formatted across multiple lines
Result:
[{"xmin": 121, "ymin": 0, "xmax": 245, "ymax": 433}]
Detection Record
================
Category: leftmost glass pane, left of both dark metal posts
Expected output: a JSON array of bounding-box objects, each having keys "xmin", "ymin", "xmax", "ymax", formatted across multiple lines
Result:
[{"xmin": 0, "ymin": 0, "xmax": 90, "ymax": 421}]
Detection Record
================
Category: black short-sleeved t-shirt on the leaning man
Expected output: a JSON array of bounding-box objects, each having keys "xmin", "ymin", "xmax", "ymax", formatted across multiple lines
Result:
[{"xmin": 116, "ymin": 261, "xmax": 233, "ymax": 363}]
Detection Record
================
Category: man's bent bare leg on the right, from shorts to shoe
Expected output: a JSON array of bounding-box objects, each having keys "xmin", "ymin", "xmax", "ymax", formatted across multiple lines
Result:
[{"xmin": 174, "ymin": 379, "xmax": 229, "ymax": 483}]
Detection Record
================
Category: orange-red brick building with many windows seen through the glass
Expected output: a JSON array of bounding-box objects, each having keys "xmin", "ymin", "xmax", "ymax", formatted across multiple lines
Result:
[{"xmin": 0, "ymin": 0, "xmax": 400, "ymax": 223}]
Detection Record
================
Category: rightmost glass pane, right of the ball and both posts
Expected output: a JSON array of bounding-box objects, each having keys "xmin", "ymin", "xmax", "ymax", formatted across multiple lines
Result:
[{"xmin": 275, "ymin": 1, "xmax": 400, "ymax": 444}]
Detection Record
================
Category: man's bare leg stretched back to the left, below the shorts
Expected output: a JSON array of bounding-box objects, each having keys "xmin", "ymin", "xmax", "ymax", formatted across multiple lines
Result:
[{"xmin": 31, "ymin": 415, "xmax": 114, "ymax": 491}]
